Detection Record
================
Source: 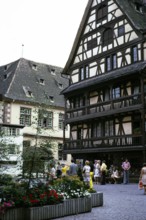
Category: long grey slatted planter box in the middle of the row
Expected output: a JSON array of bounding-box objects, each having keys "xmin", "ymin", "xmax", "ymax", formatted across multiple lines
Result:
[{"xmin": 25, "ymin": 198, "xmax": 92, "ymax": 220}]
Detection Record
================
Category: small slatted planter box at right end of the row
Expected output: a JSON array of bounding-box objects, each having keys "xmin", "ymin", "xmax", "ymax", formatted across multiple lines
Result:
[{"xmin": 91, "ymin": 192, "xmax": 103, "ymax": 207}]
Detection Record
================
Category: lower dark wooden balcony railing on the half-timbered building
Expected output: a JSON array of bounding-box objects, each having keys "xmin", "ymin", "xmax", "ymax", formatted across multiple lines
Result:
[{"xmin": 64, "ymin": 135, "xmax": 142, "ymax": 150}]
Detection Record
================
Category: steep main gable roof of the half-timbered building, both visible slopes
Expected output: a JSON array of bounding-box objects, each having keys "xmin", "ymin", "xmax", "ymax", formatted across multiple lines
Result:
[{"xmin": 62, "ymin": 0, "xmax": 146, "ymax": 74}]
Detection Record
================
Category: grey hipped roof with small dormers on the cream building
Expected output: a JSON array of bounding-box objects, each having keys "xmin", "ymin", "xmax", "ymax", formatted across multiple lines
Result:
[{"xmin": 0, "ymin": 58, "xmax": 68, "ymax": 107}]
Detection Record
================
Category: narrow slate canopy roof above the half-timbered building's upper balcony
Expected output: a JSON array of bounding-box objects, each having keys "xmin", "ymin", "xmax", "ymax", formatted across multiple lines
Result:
[{"xmin": 62, "ymin": 62, "xmax": 146, "ymax": 94}]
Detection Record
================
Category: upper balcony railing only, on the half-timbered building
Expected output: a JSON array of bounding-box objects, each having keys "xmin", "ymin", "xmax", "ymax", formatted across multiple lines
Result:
[{"xmin": 66, "ymin": 94, "xmax": 142, "ymax": 119}]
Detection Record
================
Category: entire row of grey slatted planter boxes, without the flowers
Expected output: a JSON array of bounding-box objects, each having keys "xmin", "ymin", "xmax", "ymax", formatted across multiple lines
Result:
[{"xmin": 0, "ymin": 192, "xmax": 103, "ymax": 220}]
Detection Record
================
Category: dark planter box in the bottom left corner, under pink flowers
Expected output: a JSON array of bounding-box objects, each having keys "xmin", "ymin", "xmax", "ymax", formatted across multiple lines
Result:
[{"xmin": 0, "ymin": 208, "xmax": 24, "ymax": 220}]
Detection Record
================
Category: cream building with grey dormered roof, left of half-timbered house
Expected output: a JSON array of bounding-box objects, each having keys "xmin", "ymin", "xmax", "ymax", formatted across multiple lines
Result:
[{"xmin": 0, "ymin": 58, "xmax": 70, "ymax": 172}]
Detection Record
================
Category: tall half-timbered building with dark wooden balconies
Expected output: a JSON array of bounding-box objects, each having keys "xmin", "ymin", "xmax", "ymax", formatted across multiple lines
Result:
[{"xmin": 62, "ymin": 0, "xmax": 146, "ymax": 168}]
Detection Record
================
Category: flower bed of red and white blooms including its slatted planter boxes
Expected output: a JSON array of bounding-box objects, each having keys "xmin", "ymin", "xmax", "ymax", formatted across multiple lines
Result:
[{"xmin": 0, "ymin": 178, "xmax": 103, "ymax": 220}]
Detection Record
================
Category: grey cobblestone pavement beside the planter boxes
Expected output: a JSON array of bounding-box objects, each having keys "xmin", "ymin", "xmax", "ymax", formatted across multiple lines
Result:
[{"xmin": 56, "ymin": 184, "xmax": 146, "ymax": 220}]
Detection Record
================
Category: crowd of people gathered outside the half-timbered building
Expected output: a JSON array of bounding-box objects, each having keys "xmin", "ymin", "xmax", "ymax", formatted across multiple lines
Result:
[{"xmin": 49, "ymin": 158, "xmax": 146, "ymax": 194}]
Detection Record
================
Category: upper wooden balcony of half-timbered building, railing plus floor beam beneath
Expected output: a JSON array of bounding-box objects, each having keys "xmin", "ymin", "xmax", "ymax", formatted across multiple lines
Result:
[{"xmin": 66, "ymin": 95, "xmax": 142, "ymax": 123}]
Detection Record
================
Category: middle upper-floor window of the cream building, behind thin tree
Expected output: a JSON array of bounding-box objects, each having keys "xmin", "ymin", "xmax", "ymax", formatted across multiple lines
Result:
[{"xmin": 38, "ymin": 111, "xmax": 53, "ymax": 128}]
